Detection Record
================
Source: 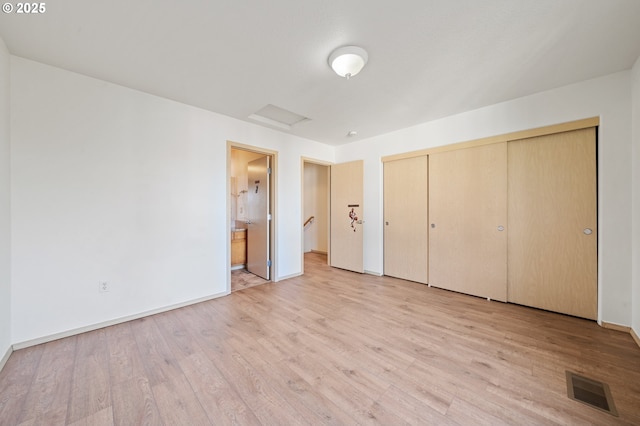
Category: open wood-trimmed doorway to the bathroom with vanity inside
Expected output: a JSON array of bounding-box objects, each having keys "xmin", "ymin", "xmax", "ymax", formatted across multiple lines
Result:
[{"xmin": 227, "ymin": 142, "xmax": 276, "ymax": 292}]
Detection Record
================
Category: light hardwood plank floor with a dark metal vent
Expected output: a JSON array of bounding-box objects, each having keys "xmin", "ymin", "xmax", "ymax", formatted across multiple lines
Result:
[{"xmin": 0, "ymin": 254, "xmax": 640, "ymax": 425}]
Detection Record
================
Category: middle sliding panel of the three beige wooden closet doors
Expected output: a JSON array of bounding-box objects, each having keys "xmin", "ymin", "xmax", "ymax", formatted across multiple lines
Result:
[{"xmin": 429, "ymin": 142, "xmax": 509, "ymax": 301}]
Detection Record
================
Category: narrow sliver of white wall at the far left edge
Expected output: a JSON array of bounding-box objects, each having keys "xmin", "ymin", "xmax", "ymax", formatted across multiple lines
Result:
[{"xmin": 0, "ymin": 38, "xmax": 12, "ymax": 362}]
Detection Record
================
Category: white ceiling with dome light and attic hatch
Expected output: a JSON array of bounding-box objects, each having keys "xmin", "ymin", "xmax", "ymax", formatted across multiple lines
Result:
[{"xmin": 0, "ymin": 0, "xmax": 640, "ymax": 145}]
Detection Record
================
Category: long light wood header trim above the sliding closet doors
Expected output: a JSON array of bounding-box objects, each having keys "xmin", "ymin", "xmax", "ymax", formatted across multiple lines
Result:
[{"xmin": 382, "ymin": 117, "xmax": 600, "ymax": 163}]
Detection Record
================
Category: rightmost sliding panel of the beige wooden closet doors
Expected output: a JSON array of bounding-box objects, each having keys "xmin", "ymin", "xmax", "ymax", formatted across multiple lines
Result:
[{"xmin": 509, "ymin": 128, "xmax": 598, "ymax": 319}]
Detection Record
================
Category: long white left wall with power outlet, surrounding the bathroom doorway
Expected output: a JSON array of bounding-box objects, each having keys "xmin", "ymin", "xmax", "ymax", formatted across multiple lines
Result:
[{"xmin": 11, "ymin": 56, "xmax": 334, "ymax": 343}]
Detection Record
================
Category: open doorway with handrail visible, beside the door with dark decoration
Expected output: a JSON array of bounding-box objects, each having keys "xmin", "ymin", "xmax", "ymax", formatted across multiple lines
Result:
[{"xmin": 301, "ymin": 159, "xmax": 331, "ymax": 273}]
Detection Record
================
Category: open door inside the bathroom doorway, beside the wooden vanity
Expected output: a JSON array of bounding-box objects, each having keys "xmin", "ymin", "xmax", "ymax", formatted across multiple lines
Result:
[{"xmin": 247, "ymin": 156, "xmax": 271, "ymax": 280}]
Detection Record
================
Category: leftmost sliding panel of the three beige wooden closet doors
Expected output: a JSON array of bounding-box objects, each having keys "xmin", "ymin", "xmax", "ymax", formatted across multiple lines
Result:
[{"xmin": 384, "ymin": 156, "xmax": 429, "ymax": 284}]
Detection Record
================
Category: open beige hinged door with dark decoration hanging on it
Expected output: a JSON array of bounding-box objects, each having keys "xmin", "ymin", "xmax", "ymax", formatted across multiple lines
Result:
[{"xmin": 329, "ymin": 161, "xmax": 364, "ymax": 273}]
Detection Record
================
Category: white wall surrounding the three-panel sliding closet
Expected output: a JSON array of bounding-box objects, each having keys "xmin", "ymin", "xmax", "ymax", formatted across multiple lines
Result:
[{"xmin": 336, "ymin": 71, "xmax": 631, "ymax": 326}]
